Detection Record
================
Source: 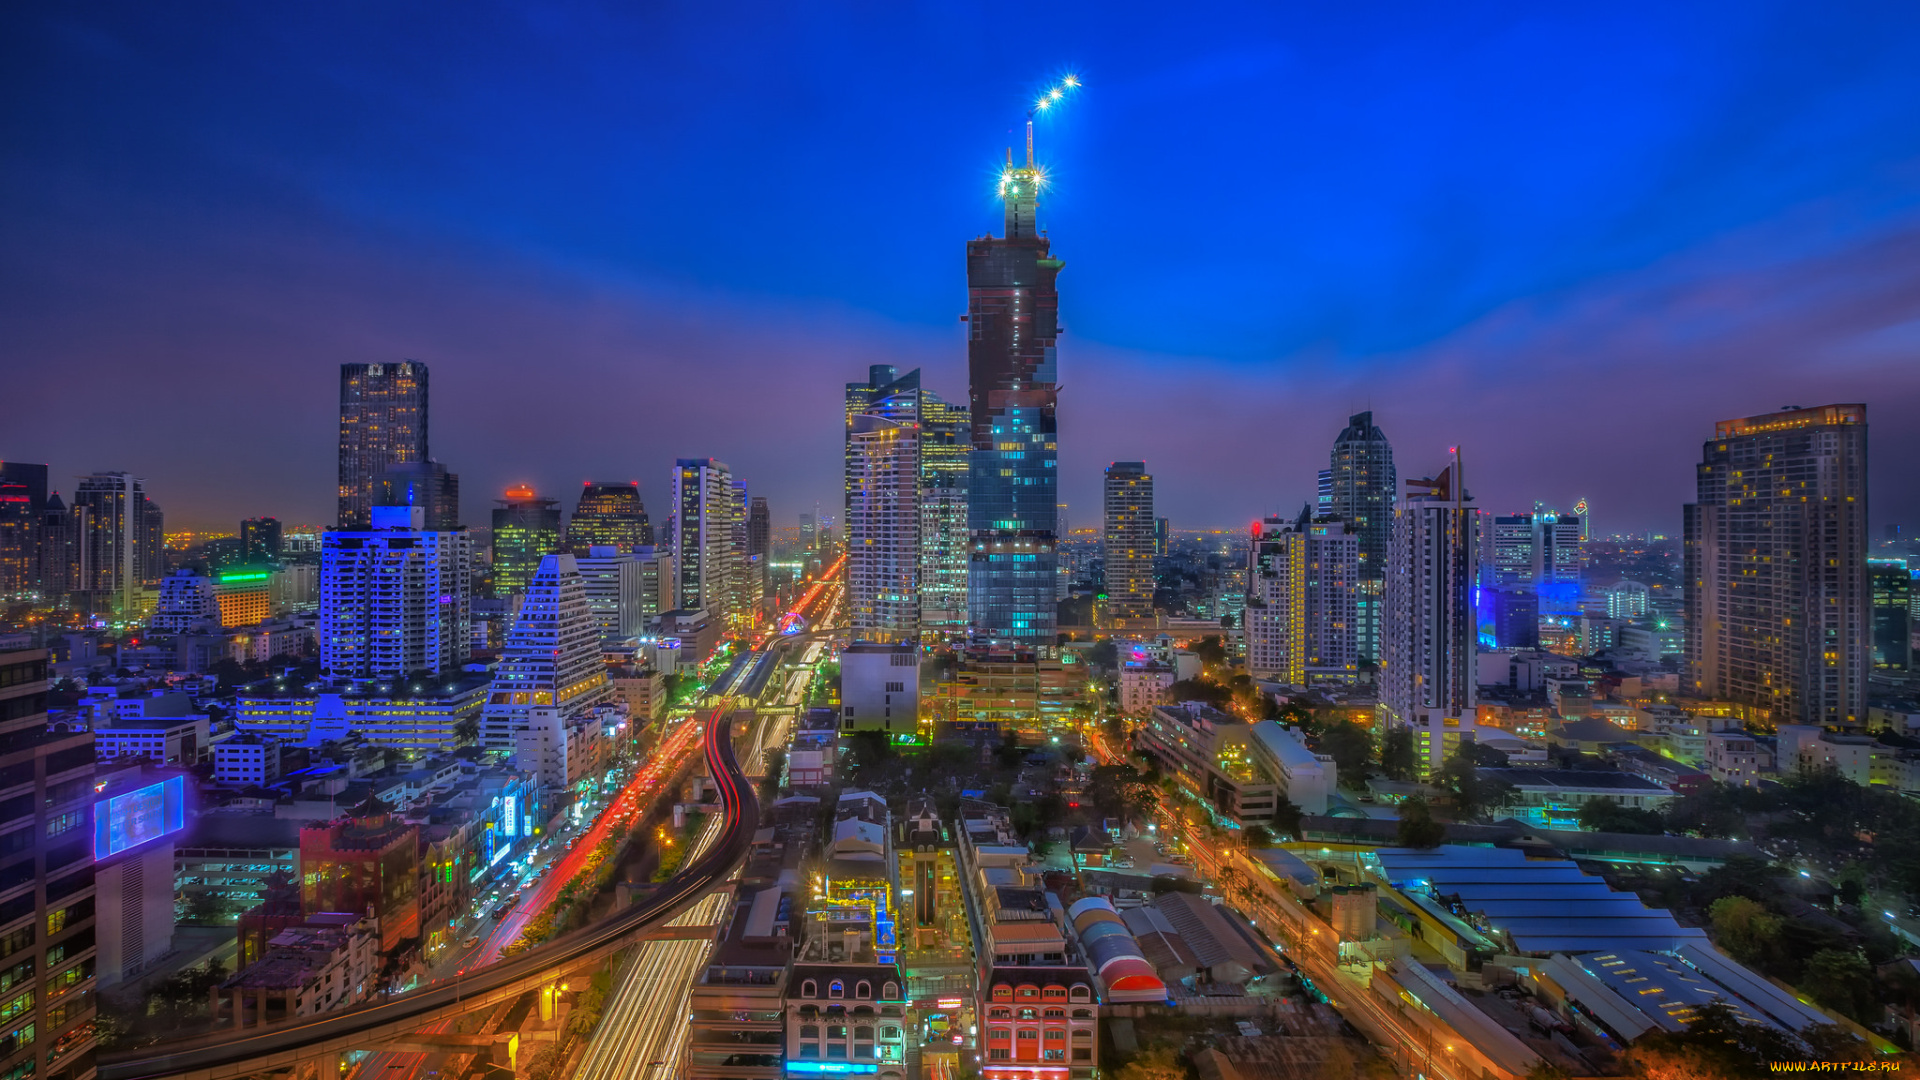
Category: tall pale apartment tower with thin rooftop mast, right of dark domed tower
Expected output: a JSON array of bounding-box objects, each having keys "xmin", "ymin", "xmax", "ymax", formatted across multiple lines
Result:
[{"xmin": 1390, "ymin": 457, "xmax": 1480, "ymax": 773}]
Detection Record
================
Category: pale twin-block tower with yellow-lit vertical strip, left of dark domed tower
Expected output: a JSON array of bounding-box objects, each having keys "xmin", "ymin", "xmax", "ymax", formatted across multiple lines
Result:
[{"xmin": 1244, "ymin": 507, "xmax": 1359, "ymax": 686}]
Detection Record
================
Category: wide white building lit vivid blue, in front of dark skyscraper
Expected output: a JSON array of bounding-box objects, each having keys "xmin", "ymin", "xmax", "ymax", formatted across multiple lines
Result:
[{"xmin": 321, "ymin": 505, "xmax": 472, "ymax": 680}]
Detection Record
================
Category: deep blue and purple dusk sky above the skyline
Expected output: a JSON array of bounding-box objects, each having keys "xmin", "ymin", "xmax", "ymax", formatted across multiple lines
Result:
[{"xmin": 0, "ymin": 0, "xmax": 1920, "ymax": 532}]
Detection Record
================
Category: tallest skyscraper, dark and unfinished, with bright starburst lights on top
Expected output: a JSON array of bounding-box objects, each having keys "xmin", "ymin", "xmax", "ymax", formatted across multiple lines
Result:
[{"xmin": 966, "ymin": 123, "xmax": 1064, "ymax": 646}]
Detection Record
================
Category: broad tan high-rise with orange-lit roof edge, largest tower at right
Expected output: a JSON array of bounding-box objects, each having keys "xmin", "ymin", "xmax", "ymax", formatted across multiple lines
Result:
[{"xmin": 1684, "ymin": 405, "xmax": 1872, "ymax": 726}]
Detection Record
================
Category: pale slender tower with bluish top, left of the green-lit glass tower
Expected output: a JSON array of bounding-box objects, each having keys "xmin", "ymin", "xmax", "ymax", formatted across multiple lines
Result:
[{"xmin": 845, "ymin": 401, "xmax": 920, "ymax": 644}]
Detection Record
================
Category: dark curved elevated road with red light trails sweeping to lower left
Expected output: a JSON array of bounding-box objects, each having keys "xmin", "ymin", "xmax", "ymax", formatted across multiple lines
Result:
[{"xmin": 100, "ymin": 705, "xmax": 760, "ymax": 1080}]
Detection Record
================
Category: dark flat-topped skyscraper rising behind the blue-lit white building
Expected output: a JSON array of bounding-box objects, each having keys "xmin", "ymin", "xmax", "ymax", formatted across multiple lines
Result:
[{"xmin": 340, "ymin": 359, "xmax": 426, "ymax": 528}]
